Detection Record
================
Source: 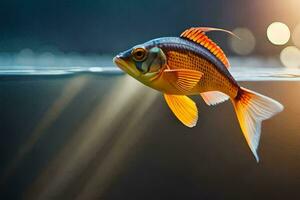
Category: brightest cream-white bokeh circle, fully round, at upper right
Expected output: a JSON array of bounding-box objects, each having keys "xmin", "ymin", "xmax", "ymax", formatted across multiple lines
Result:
[{"xmin": 267, "ymin": 22, "xmax": 291, "ymax": 45}]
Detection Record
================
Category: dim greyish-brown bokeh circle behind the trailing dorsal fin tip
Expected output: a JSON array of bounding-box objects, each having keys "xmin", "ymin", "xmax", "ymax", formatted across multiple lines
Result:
[{"xmin": 229, "ymin": 28, "xmax": 256, "ymax": 55}]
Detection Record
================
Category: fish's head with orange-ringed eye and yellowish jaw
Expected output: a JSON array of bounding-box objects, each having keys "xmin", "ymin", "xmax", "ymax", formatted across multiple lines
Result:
[{"xmin": 113, "ymin": 43, "xmax": 166, "ymax": 85}]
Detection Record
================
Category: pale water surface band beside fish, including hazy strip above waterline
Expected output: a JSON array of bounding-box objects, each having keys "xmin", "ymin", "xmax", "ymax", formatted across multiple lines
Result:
[{"xmin": 0, "ymin": 56, "xmax": 300, "ymax": 81}]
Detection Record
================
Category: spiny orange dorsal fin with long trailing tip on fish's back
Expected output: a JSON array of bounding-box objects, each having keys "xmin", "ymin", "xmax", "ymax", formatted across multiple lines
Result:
[{"xmin": 180, "ymin": 27, "xmax": 233, "ymax": 68}]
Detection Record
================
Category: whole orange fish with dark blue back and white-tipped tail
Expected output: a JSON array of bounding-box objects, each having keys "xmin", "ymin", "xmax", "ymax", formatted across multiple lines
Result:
[{"xmin": 113, "ymin": 27, "xmax": 284, "ymax": 162}]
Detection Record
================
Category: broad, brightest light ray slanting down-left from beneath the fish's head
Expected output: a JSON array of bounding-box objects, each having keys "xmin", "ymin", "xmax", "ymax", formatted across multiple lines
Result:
[{"xmin": 28, "ymin": 76, "xmax": 156, "ymax": 199}]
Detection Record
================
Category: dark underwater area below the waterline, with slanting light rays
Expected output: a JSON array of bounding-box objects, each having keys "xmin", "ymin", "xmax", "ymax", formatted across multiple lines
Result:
[{"xmin": 0, "ymin": 70, "xmax": 300, "ymax": 200}]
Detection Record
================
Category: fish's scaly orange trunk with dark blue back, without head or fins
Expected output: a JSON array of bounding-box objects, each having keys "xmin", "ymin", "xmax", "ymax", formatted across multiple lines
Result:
[{"xmin": 144, "ymin": 37, "xmax": 239, "ymax": 98}]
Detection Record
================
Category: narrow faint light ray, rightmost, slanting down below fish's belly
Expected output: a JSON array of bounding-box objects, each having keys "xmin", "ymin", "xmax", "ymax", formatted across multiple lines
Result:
[{"xmin": 76, "ymin": 91, "xmax": 158, "ymax": 200}]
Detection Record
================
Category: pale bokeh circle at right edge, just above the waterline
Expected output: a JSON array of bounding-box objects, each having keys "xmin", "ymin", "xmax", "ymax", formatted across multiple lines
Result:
[{"xmin": 280, "ymin": 46, "xmax": 300, "ymax": 68}]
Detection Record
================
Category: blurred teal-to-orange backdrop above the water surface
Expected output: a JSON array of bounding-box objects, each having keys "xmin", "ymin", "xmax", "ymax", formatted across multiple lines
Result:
[{"xmin": 0, "ymin": 0, "xmax": 300, "ymax": 67}]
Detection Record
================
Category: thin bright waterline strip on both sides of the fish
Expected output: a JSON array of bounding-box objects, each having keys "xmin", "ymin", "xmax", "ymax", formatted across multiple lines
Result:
[{"xmin": 0, "ymin": 66, "xmax": 300, "ymax": 81}]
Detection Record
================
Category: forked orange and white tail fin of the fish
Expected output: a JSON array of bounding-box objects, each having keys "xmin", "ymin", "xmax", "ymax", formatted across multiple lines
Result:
[{"xmin": 232, "ymin": 87, "xmax": 283, "ymax": 162}]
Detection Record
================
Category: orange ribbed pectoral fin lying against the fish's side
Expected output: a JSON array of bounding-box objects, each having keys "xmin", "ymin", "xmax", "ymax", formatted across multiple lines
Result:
[{"xmin": 163, "ymin": 69, "xmax": 203, "ymax": 92}]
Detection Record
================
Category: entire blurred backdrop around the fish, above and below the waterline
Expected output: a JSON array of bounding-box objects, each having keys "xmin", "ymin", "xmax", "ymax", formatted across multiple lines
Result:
[{"xmin": 0, "ymin": 0, "xmax": 300, "ymax": 200}]
